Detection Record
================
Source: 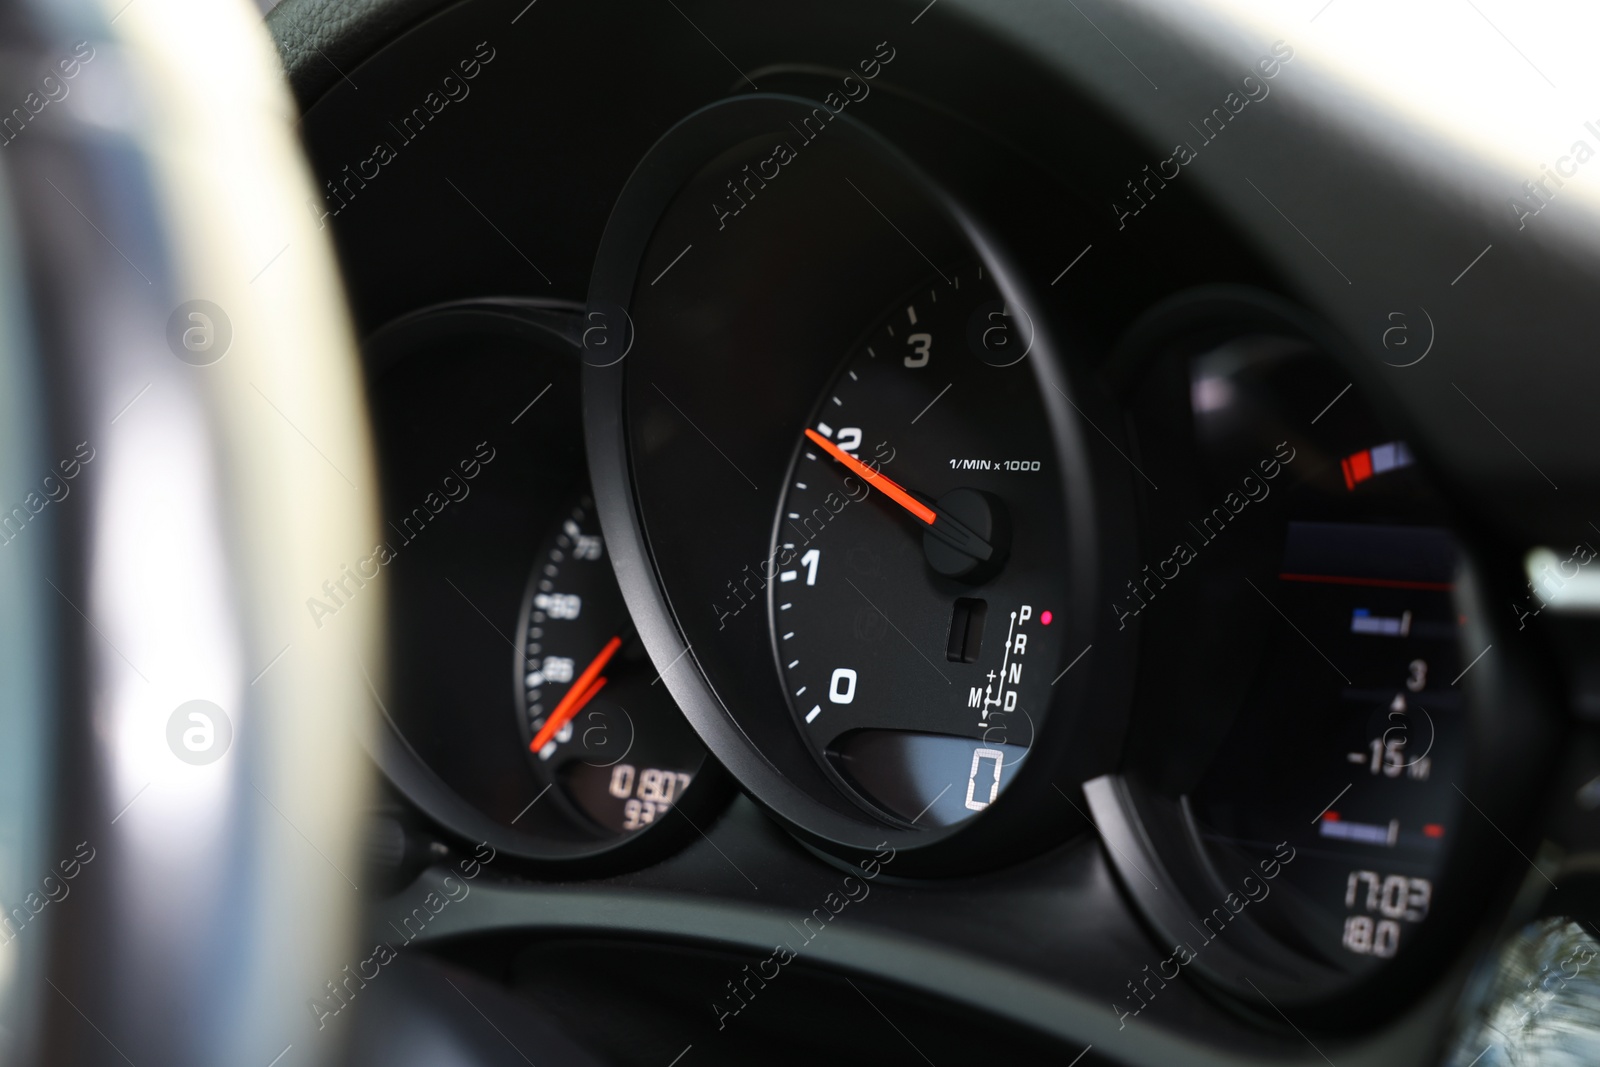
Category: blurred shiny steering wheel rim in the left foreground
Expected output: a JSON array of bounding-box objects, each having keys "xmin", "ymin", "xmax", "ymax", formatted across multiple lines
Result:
[{"xmin": 0, "ymin": 0, "xmax": 382, "ymax": 1067}]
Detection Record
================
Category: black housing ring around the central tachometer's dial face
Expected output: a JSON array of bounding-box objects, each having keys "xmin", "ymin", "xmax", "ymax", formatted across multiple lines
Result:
[{"xmin": 584, "ymin": 94, "xmax": 1158, "ymax": 875}]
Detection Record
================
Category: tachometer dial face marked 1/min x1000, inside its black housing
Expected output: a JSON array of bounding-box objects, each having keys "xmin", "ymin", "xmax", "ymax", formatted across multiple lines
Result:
[{"xmin": 768, "ymin": 267, "xmax": 1078, "ymax": 827}]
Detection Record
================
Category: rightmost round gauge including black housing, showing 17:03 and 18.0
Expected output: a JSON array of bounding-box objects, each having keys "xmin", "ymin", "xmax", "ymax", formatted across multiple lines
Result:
[{"xmin": 1085, "ymin": 288, "xmax": 1552, "ymax": 1027}]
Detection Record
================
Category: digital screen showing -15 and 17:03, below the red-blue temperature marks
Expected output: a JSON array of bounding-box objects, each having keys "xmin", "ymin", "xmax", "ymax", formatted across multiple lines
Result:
[{"xmin": 1192, "ymin": 522, "xmax": 1464, "ymax": 968}]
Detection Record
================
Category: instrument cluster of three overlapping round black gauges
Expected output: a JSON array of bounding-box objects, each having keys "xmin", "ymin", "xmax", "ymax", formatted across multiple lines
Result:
[{"xmin": 356, "ymin": 87, "xmax": 1515, "ymax": 1021}]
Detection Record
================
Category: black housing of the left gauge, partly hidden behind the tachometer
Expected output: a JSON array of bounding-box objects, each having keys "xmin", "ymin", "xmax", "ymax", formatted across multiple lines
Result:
[{"xmin": 365, "ymin": 299, "xmax": 728, "ymax": 873}]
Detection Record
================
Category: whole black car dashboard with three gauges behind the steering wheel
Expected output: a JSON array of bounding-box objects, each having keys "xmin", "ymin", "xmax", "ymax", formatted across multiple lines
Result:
[{"xmin": 259, "ymin": 0, "xmax": 1600, "ymax": 1067}]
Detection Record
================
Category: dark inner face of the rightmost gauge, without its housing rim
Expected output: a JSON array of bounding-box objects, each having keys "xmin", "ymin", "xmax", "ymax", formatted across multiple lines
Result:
[{"xmin": 1155, "ymin": 336, "xmax": 1470, "ymax": 974}]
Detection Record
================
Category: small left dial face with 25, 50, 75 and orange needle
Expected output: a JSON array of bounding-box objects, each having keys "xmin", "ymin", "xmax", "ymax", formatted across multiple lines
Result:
[{"xmin": 512, "ymin": 496, "xmax": 704, "ymax": 833}]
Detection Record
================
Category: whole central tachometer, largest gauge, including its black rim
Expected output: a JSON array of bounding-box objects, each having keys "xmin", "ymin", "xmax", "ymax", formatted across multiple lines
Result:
[{"xmin": 584, "ymin": 94, "xmax": 1136, "ymax": 875}]
